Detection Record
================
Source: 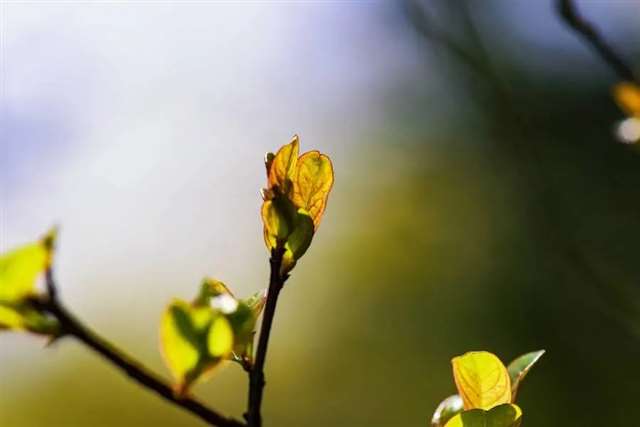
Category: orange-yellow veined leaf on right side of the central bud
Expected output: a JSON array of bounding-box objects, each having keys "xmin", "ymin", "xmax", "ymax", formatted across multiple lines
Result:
[{"xmin": 292, "ymin": 150, "xmax": 333, "ymax": 229}]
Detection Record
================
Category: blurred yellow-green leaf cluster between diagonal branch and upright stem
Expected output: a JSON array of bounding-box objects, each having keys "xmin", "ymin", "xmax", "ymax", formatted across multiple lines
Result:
[{"xmin": 160, "ymin": 300, "xmax": 233, "ymax": 394}]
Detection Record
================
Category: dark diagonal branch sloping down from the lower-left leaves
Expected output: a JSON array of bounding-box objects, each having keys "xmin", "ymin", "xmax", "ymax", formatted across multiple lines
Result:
[{"xmin": 31, "ymin": 269, "xmax": 245, "ymax": 427}]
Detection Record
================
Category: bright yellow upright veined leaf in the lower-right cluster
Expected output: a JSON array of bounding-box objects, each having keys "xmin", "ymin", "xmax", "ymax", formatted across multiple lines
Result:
[{"xmin": 451, "ymin": 351, "xmax": 511, "ymax": 409}]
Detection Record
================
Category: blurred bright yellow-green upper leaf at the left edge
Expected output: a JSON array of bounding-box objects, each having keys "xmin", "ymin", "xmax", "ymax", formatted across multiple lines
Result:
[{"xmin": 0, "ymin": 230, "xmax": 55, "ymax": 302}]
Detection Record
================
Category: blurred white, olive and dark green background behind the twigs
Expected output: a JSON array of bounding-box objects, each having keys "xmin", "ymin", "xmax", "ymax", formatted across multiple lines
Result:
[{"xmin": 0, "ymin": 0, "xmax": 640, "ymax": 427}]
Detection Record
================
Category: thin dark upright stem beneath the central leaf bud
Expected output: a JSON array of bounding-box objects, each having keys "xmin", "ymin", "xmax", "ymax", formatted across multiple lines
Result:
[{"xmin": 245, "ymin": 248, "xmax": 289, "ymax": 427}]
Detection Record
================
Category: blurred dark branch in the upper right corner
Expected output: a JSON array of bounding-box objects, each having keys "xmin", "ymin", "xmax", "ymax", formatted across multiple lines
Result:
[{"xmin": 556, "ymin": 0, "xmax": 640, "ymax": 83}]
